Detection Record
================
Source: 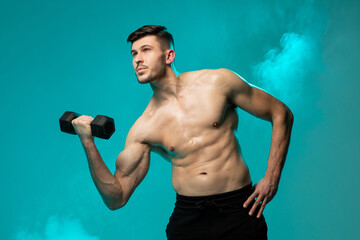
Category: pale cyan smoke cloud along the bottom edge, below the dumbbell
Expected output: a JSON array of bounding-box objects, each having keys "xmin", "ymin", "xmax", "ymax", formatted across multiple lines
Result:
[{"xmin": 15, "ymin": 216, "xmax": 99, "ymax": 240}]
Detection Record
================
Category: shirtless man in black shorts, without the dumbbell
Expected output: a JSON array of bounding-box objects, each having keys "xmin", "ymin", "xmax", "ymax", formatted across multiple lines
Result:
[{"xmin": 72, "ymin": 25, "xmax": 293, "ymax": 239}]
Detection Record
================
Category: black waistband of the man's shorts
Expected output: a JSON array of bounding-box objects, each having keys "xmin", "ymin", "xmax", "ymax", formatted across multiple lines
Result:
[{"xmin": 176, "ymin": 183, "xmax": 253, "ymax": 203}]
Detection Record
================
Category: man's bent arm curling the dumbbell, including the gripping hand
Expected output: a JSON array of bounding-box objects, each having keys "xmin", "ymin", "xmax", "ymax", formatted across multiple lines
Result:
[{"xmin": 73, "ymin": 116, "xmax": 150, "ymax": 210}]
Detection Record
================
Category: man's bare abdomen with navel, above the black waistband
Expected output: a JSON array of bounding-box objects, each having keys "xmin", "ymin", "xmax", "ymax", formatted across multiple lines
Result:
[{"xmin": 171, "ymin": 130, "xmax": 251, "ymax": 196}]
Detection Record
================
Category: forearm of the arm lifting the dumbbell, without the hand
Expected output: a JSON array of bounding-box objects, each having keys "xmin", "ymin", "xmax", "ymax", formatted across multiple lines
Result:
[{"xmin": 81, "ymin": 139, "xmax": 123, "ymax": 209}]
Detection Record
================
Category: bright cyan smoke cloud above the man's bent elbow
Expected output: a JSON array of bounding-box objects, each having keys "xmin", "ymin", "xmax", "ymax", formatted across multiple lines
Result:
[{"xmin": 254, "ymin": 32, "xmax": 314, "ymax": 99}]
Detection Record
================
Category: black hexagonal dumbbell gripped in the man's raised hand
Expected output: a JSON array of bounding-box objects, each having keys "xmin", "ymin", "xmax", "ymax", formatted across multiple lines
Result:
[{"xmin": 59, "ymin": 111, "xmax": 115, "ymax": 139}]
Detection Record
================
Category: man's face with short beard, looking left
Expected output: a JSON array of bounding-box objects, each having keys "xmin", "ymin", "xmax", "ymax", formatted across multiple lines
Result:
[{"xmin": 131, "ymin": 36, "xmax": 165, "ymax": 83}]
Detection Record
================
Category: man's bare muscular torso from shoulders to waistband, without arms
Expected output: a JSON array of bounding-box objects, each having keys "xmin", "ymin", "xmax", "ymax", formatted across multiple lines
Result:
[{"xmin": 137, "ymin": 70, "xmax": 251, "ymax": 196}]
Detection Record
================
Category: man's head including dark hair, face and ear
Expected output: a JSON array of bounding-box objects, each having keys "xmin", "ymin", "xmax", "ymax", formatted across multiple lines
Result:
[{"xmin": 127, "ymin": 25, "xmax": 175, "ymax": 83}]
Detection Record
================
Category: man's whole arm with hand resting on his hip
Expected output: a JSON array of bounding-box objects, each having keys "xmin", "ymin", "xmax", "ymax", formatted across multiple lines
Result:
[{"xmin": 218, "ymin": 69, "xmax": 294, "ymax": 218}]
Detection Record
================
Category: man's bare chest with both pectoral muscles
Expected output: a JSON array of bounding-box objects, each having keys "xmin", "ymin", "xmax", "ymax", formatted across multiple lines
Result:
[{"xmin": 142, "ymin": 88, "xmax": 237, "ymax": 158}]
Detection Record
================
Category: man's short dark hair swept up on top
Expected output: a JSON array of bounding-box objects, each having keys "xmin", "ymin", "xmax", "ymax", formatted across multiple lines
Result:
[{"xmin": 127, "ymin": 25, "xmax": 175, "ymax": 50}]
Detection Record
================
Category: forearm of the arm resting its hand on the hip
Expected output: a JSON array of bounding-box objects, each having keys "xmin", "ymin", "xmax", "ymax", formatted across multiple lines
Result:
[{"xmin": 265, "ymin": 110, "xmax": 294, "ymax": 184}]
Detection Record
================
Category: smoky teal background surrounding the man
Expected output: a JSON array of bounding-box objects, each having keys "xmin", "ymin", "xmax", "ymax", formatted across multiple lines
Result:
[{"xmin": 0, "ymin": 0, "xmax": 360, "ymax": 240}]
